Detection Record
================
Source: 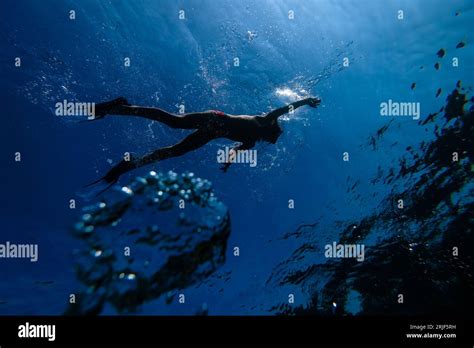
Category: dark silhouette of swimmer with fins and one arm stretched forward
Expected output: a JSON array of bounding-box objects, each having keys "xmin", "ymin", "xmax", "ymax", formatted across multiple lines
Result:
[{"xmin": 90, "ymin": 97, "xmax": 321, "ymax": 186}]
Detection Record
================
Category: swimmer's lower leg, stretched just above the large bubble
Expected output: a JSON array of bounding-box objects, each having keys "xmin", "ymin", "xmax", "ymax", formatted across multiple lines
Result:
[{"xmin": 103, "ymin": 130, "xmax": 214, "ymax": 183}]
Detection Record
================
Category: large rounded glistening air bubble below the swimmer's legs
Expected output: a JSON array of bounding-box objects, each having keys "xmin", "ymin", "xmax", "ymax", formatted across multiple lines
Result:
[{"xmin": 66, "ymin": 172, "xmax": 230, "ymax": 314}]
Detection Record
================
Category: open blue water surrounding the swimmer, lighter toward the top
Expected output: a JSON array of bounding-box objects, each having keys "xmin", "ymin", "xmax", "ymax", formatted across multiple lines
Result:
[{"xmin": 0, "ymin": 0, "xmax": 474, "ymax": 315}]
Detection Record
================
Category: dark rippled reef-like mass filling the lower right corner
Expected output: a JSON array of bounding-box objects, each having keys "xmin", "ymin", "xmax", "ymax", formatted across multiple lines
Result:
[{"xmin": 268, "ymin": 83, "xmax": 474, "ymax": 316}]
